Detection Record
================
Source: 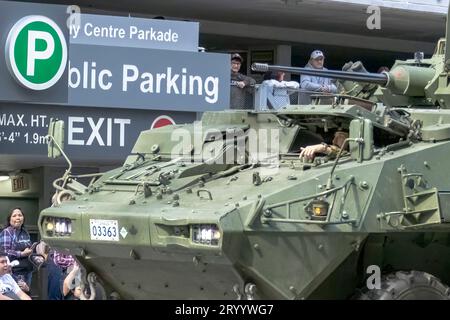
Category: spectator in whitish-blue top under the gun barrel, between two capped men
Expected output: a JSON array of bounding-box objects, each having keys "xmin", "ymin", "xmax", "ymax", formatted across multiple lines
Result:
[{"xmin": 262, "ymin": 71, "xmax": 300, "ymax": 109}]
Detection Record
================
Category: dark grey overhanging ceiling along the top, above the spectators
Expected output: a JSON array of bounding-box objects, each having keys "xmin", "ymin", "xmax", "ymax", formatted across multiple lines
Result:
[{"xmin": 30, "ymin": 0, "xmax": 445, "ymax": 42}]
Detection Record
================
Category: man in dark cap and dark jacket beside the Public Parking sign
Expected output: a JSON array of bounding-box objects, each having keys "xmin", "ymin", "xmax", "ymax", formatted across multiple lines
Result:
[{"xmin": 230, "ymin": 53, "xmax": 256, "ymax": 109}]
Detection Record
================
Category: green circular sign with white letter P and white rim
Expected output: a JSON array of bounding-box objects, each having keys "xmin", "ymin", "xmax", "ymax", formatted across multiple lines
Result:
[{"xmin": 5, "ymin": 16, "xmax": 67, "ymax": 90}]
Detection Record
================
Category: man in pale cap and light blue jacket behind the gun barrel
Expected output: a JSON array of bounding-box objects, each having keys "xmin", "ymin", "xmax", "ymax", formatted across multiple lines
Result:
[{"xmin": 300, "ymin": 50, "xmax": 337, "ymax": 93}]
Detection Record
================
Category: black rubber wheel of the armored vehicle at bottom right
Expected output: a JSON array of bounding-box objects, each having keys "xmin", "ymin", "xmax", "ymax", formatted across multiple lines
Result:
[{"xmin": 355, "ymin": 270, "xmax": 450, "ymax": 300}]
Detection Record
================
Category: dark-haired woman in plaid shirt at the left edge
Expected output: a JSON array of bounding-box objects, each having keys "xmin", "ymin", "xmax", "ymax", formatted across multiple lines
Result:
[{"xmin": 0, "ymin": 208, "xmax": 33, "ymax": 288}]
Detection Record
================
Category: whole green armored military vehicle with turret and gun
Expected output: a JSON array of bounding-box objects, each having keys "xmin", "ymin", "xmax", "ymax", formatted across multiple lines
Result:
[{"xmin": 38, "ymin": 10, "xmax": 450, "ymax": 300}]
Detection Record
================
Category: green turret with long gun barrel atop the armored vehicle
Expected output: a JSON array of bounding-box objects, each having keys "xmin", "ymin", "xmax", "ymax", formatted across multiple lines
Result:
[{"xmin": 252, "ymin": 6, "xmax": 450, "ymax": 109}]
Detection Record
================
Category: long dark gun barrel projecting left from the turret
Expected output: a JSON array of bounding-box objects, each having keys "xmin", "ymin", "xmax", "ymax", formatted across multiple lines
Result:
[{"xmin": 252, "ymin": 63, "xmax": 389, "ymax": 86}]
